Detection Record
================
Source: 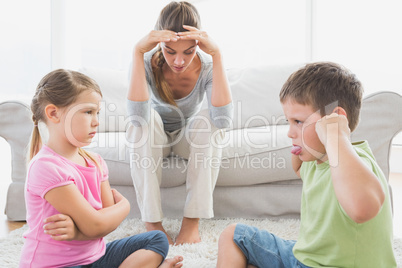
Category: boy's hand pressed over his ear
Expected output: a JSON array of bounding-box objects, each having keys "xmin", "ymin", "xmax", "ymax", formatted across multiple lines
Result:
[{"xmin": 315, "ymin": 113, "xmax": 350, "ymax": 147}]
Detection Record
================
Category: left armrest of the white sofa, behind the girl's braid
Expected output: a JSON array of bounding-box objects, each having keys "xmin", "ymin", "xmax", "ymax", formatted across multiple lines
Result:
[{"xmin": 0, "ymin": 101, "xmax": 33, "ymax": 221}]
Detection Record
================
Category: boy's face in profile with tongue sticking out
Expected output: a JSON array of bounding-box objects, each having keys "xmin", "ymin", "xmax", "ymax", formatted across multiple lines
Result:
[{"xmin": 282, "ymin": 99, "xmax": 326, "ymax": 163}]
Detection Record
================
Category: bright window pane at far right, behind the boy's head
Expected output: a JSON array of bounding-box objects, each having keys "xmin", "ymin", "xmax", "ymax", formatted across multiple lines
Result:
[{"xmin": 313, "ymin": 0, "xmax": 402, "ymax": 95}]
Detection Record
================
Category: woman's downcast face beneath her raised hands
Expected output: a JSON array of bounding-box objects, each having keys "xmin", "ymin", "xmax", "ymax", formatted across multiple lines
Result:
[{"xmin": 161, "ymin": 40, "xmax": 197, "ymax": 74}]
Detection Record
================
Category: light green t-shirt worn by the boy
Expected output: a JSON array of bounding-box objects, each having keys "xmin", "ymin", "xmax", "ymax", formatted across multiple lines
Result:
[{"xmin": 293, "ymin": 141, "xmax": 397, "ymax": 268}]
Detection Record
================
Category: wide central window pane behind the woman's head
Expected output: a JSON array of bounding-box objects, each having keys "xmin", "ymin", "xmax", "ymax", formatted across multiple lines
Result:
[{"xmin": 58, "ymin": 0, "xmax": 306, "ymax": 69}]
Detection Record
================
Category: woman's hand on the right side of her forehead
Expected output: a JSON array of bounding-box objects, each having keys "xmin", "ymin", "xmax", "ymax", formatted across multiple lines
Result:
[{"xmin": 178, "ymin": 25, "xmax": 219, "ymax": 57}]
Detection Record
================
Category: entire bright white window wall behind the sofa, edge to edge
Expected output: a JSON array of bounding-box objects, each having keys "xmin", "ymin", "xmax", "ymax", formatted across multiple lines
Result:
[{"xmin": 0, "ymin": 0, "xmax": 402, "ymax": 99}]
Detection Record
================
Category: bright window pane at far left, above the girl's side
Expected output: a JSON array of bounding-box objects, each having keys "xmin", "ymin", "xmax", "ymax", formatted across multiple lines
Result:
[{"xmin": 0, "ymin": 0, "xmax": 51, "ymax": 103}]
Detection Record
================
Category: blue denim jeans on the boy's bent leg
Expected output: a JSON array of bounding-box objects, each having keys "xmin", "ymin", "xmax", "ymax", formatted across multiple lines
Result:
[{"xmin": 233, "ymin": 224, "xmax": 308, "ymax": 268}]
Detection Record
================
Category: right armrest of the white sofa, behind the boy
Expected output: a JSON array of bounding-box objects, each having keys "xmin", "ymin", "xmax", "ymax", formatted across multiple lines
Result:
[{"xmin": 352, "ymin": 91, "xmax": 402, "ymax": 179}]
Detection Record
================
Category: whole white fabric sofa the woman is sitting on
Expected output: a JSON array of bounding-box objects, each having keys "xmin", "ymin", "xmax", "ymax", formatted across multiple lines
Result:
[{"xmin": 0, "ymin": 65, "xmax": 402, "ymax": 221}]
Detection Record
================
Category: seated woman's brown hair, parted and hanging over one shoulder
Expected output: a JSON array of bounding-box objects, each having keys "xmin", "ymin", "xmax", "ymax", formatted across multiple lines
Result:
[{"xmin": 153, "ymin": 1, "xmax": 201, "ymax": 106}]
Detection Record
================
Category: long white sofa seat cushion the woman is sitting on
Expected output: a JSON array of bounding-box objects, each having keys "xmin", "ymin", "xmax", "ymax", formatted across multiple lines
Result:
[{"xmin": 86, "ymin": 125, "xmax": 297, "ymax": 188}]
